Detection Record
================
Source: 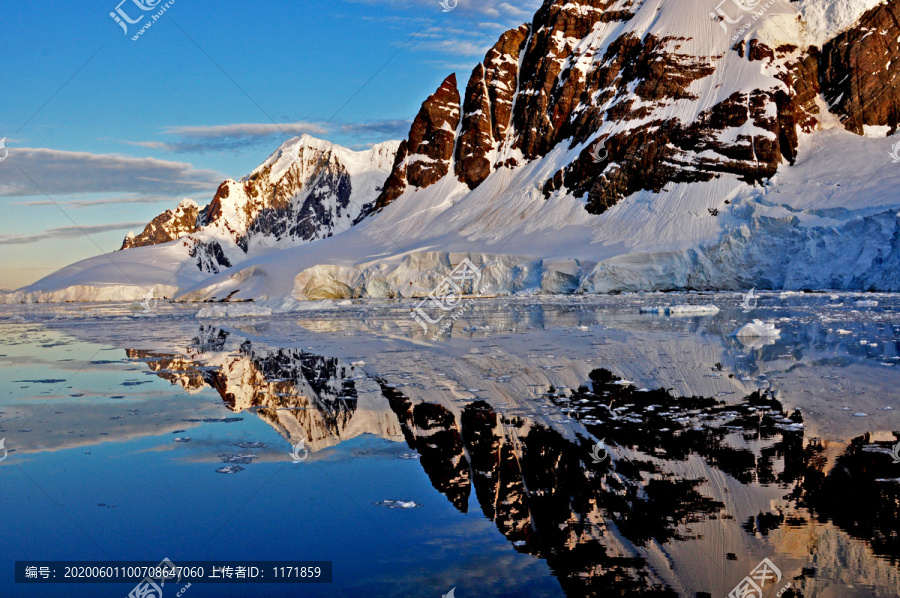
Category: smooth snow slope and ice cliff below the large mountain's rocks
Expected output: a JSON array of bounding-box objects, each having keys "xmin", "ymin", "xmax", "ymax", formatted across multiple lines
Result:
[{"xmin": 171, "ymin": 130, "xmax": 900, "ymax": 300}]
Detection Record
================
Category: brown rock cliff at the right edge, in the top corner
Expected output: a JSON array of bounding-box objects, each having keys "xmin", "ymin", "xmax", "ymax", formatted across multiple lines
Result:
[{"xmin": 819, "ymin": 1, "xmax": 900, "ymax": 134}]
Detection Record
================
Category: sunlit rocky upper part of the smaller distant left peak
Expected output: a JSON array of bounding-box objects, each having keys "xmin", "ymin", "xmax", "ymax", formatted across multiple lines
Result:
[{"xmin": 122, "ymin": 136, "xmax": 397, "ymax": 253}]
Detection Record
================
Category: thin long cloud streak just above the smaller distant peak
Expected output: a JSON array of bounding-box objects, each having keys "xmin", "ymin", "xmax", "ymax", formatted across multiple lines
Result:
[{"xmin": 128, "ymin": 119, "xmax": 412, "ymax": 153}]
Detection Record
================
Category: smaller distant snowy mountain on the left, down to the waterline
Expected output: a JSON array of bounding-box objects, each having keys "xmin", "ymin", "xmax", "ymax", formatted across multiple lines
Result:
[{"xmin": 5, "ymin": 135, "xmax": 399, "ymax": 302}]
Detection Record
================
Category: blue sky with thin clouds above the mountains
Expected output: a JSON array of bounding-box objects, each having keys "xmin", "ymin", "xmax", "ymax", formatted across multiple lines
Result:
[{"xmin": 0, "ymin": 0, "xmax": 540, "ymax": 288}]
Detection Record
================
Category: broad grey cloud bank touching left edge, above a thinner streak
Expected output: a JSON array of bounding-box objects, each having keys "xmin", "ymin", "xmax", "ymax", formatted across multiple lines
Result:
[{"xmin": 0, "ymin": 147, "xmax": 225, "ymax": 197}]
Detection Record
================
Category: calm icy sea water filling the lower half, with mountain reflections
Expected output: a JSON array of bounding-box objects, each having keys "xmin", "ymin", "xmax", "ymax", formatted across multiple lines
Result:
[{"xmin": 0, "ymin": 294, "xmax": 900, "ymax": 598}]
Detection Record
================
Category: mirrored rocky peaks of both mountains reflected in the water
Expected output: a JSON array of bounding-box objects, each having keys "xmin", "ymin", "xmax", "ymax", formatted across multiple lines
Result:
[{"xmin": 127, "ymin": 327, "xmax": 900, "ymax": 597}]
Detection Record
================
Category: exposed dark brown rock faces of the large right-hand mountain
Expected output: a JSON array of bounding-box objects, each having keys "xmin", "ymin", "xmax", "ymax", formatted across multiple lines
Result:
[{"xmin": 379, "ymin": 0, "xmax": 900, "ymax": 214}]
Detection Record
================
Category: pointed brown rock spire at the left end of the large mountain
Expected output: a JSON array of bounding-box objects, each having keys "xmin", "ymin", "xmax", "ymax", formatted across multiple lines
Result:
[{"xmin": 375, "ymin": 73, "xmax": 459, "ymax": 211}]
